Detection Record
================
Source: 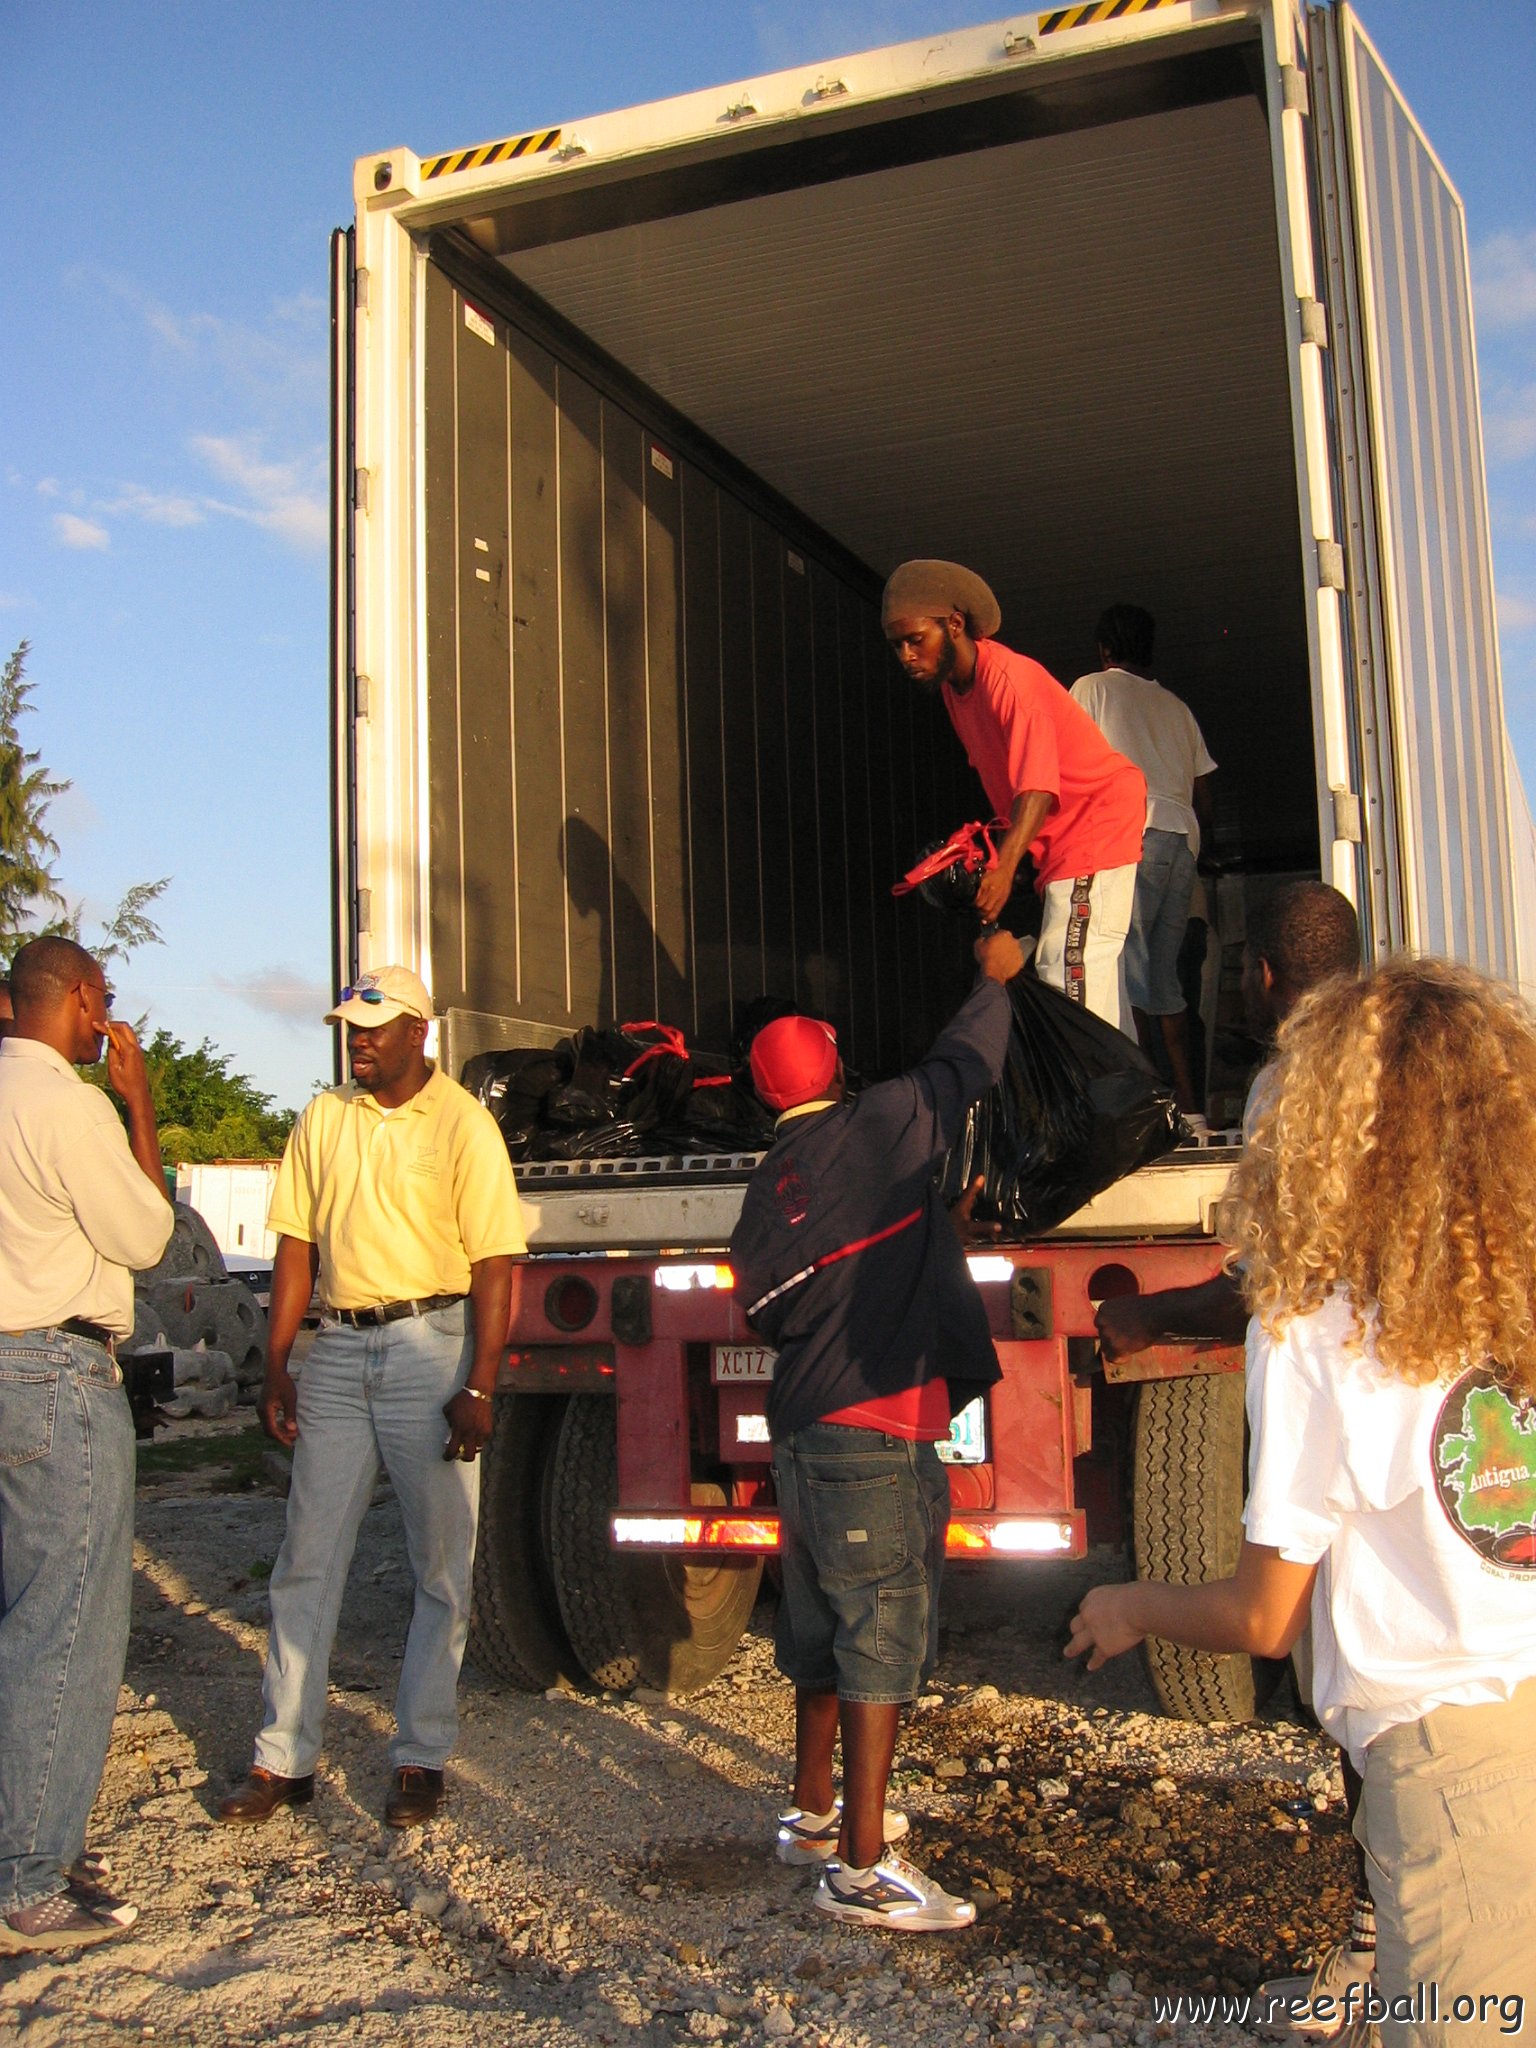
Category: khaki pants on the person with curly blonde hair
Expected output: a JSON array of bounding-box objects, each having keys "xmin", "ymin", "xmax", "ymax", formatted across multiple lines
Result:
[{"xmin": 1354, "ymin": 1679, "xmax": 1536, "ymax": 2048}]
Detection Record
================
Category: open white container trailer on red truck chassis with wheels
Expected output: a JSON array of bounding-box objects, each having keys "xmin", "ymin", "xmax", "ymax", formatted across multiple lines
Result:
[{"xmin": 332, "ymin": 0, "xmax": 1536, "ymax": 1718}]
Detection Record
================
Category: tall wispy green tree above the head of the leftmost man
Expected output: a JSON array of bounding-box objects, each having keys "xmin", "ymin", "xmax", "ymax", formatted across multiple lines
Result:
[{"xmin": 0, "ymin": 641, "xmax": 170, "ymax": 963}]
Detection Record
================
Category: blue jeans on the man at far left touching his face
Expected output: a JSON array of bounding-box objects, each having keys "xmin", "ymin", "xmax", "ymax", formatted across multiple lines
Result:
[{"xmin": 0, "ymin": 1329, "xmax": 135, "ymax": 1913}]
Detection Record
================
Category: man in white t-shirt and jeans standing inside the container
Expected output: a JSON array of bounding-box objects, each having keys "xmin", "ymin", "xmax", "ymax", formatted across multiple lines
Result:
[{"xmin": 1071, "ymin": 604, "xmax": 1217, "ymax": 1130}]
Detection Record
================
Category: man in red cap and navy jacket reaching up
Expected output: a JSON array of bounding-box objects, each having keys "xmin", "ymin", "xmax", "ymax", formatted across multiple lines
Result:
[{"xmin": 731, "ymin": 932, "xmax": 1024, "ymax": 1929}]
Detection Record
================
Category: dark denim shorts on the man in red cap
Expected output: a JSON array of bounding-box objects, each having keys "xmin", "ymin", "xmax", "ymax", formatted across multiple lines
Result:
[{"xmin": 774, "ymin": 1421, "xmax": 950, "ymax": 1706}]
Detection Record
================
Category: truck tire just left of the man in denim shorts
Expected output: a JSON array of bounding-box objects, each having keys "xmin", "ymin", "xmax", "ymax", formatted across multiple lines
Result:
[{"xmin": 551, "ymin": 1395, "xmax": 762, "ymax": 1696}]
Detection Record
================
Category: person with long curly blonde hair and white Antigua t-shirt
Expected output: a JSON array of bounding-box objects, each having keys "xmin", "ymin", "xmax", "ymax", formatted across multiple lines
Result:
[{"xmin": 1067, "ymin": 961, "xmax": 1536, "ymax": 2044}]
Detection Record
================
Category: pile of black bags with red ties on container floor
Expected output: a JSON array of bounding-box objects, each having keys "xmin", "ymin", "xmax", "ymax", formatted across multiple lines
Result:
[{"xmin": 463, "ymin": 1024, "xmax": 774, "ymax": 1161}]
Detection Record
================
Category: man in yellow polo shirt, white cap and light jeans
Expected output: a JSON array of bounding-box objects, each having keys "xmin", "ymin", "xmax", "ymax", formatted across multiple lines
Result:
[{"xmin": 219, "ymin": 967, "xmax": 526, "ymax": 1827}]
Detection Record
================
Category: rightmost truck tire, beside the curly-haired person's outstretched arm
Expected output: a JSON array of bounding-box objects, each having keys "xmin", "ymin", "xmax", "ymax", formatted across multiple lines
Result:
[{"xmin": 1130, "ymin": 1372, "xmax": 1284, "ymax": 1720}]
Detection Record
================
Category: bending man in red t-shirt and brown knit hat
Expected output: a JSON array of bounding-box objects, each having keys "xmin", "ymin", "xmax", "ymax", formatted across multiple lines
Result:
[{"xmin": 881, "ymin": 561, "xmax": 1147, "ymax": 1034}]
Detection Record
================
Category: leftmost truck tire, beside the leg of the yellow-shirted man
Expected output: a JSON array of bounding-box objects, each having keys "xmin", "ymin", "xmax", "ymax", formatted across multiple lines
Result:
[{"xmin": 467, "ymin": 1395, "xmax": 586, "ymax": 1692}]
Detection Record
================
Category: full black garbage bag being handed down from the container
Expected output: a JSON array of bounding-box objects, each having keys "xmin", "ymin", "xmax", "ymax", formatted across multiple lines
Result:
[{"xmin": 940, "ymin": 971, "xmax": 1180, "ymax": 1235}]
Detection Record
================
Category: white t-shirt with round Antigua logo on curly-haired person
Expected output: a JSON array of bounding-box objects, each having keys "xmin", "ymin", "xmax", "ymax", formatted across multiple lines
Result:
[{"xmin": 1243, "ymin": 1292, "xmax": 1536, "ymax": 1769}]
